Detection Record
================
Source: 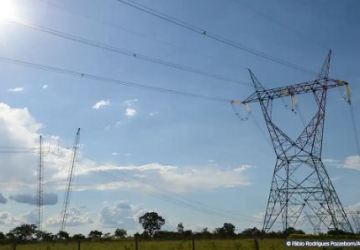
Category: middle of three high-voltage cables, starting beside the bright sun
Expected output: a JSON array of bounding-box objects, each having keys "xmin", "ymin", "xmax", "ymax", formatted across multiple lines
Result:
[{"xmin": 8, "ymin": 20, "xmax": 249, "ymax": 86}]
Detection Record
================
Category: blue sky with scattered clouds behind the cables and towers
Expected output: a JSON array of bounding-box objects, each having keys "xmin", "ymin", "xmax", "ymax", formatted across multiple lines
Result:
[{"xmin": 0, "ymin": 0, "xmax": 360, "ymax": 234}]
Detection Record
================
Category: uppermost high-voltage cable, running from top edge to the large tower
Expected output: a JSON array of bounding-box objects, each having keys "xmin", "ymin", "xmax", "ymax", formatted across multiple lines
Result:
[{"xmin": 116, "ymin": 0, "xmax": 317, "ymax": 75}]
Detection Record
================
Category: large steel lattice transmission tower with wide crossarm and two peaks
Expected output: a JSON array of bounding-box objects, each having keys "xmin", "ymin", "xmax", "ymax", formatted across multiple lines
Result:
[{"xmin": 233, "ymin": 51, "xmax": 353, "ymax": 232}]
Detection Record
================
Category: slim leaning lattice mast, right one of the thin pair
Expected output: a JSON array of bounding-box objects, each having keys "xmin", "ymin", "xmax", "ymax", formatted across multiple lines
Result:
[{"xmin": 60, "ymin": 128, "xmax": 80, "ymax": 231}]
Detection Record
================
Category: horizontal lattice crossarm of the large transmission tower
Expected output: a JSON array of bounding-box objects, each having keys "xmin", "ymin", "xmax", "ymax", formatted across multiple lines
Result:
[{"xmin": 239, "ymin": 78, "xmax": 348, "ymax": 104}]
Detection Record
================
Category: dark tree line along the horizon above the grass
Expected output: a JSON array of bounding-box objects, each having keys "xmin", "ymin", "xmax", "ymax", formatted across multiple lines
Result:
[{"xmin": 0, "ymin": 212, "xmax": 351, "ymax": 243}]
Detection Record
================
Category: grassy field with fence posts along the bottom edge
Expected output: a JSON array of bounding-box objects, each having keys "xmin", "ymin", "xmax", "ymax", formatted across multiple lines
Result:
[{"xmin": 0, "ymin": 239, "xmax": 359, "ymax": 250}]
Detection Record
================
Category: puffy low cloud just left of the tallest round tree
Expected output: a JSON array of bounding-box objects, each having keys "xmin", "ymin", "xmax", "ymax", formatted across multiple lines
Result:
[{"xmin": 100, "ymin": 201, "xmax": 142, "ymax": 230}]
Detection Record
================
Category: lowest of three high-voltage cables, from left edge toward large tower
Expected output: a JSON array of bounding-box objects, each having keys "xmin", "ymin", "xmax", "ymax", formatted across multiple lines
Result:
[{"xmin": 0, "ymin": 56, "xmax": 231, "ymax": 103}]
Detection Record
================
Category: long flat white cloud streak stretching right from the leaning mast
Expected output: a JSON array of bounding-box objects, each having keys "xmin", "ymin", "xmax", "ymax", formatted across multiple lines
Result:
[{"xmin": 71, "ymin": 163, "xmax": 251, "ymax": 193}]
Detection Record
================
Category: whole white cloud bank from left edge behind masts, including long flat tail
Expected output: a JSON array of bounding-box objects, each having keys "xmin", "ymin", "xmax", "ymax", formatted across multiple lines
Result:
[{"xmin": 0, "ymin": 103, "xmax": 251, "ymax": 195}]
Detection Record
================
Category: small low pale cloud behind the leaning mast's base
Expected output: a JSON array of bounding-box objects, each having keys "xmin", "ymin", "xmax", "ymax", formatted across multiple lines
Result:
[{"xmin": 45, "ymin": 208, "xmax": 94, "ymax": 227}]
